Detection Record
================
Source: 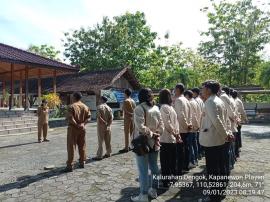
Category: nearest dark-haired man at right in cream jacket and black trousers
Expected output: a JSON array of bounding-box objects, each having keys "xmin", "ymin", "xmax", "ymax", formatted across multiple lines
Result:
[{"xmin": 199, "ymin": 81, "xmax": 230, "ymax": 202}]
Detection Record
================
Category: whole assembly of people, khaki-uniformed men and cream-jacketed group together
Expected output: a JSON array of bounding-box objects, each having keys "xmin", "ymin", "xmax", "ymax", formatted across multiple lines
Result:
[{"xmin": 38, "ymin": 80, "xmax": 247, "ymax": 202}]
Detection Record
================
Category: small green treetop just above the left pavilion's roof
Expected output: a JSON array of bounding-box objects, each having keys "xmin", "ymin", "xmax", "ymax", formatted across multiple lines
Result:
[{"xmin": 28, "ymin": 44, "xmax": 60, "ymax": 60}]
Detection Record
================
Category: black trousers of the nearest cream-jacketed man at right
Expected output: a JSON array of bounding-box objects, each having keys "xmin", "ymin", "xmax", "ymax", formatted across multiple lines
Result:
[{"xmin": 204, "ymin": 144, "xmax": 227, "ymax": 201}]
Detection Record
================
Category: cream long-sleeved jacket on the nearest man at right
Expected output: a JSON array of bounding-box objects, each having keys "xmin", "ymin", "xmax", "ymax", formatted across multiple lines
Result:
[{"xmin": 199, "ymin": 95, "xmax": 228, "ymax": 147}]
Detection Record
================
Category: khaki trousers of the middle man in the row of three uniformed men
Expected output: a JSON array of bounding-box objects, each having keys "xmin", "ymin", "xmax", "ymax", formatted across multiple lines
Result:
[{"xmin": 97, "ymin": 124, "xmax": 112, "ymax": 158}]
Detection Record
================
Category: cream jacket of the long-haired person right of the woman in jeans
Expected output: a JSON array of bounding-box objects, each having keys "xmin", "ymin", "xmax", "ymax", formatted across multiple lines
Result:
[{"xmin": 160, "ymin": 104, "xmax": 179, "ymax": 143}]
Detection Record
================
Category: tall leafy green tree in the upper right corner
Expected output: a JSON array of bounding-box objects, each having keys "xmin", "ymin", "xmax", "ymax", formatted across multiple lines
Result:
[{"xmin": 199, "ymin": 0, "xmax": 270, "ymax": 85}]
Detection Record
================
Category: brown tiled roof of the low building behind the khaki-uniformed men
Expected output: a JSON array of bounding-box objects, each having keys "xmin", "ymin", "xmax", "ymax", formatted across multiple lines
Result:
[{"xmin": 57, "ymin": 67, "xmax": 140, "ymax": 92}]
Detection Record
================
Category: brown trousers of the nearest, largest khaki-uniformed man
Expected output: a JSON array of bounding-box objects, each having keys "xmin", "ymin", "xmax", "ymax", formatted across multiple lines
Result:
[{"xmin": 67, "ymin": 126, "xmax": 86, "ymax": 168}]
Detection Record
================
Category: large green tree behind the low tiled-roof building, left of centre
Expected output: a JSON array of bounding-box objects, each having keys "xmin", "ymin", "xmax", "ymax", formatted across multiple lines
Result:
[{"xmin": 63, "ymin": 12, "xmax": 157, "ymax": 73}]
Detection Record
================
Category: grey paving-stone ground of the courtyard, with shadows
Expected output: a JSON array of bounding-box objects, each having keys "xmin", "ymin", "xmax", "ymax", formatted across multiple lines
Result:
[{"xmin": 0, "ymin": 121, "xmax": 270, "ymax": 202}]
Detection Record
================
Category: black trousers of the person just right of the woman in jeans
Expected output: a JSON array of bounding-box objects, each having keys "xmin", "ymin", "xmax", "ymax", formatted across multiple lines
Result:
[{"xmin": 160, "ymin": 143, "xmax": 176, "ymax": 187}]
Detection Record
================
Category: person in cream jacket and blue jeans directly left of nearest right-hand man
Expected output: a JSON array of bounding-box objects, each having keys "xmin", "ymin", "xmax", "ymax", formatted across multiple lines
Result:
[{"xmin": 184, "ymin": 90, "xmax": 200, "ymax": 169}]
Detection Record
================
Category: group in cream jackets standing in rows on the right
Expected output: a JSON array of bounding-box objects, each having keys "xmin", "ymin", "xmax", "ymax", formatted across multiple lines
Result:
[{"xmin": 131, "ymin": 81, "xmax": 247, "ymax": 202}]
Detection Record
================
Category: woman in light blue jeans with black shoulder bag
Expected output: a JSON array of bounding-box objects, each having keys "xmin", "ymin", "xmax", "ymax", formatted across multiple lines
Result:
[{"xmin": 131, "ymin": 88, "xmax": 164, "ymax": 202}]
